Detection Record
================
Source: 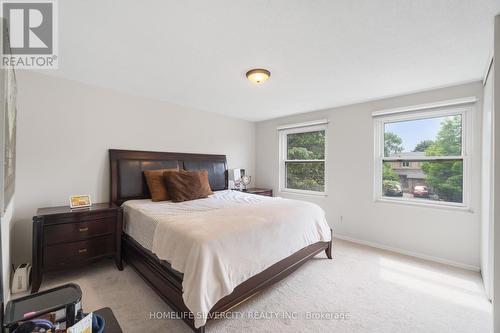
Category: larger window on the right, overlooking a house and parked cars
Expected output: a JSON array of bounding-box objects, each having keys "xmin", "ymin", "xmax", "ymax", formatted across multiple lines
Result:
[{"xmin": 374, "ymin": 103, "xmax": 472, "ymax": 206}]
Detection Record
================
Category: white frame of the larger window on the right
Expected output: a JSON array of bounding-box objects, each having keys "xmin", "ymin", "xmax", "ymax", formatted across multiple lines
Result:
[{"xmin": 373, "ymin": 102, "xmax": 475, "ymax": 210}]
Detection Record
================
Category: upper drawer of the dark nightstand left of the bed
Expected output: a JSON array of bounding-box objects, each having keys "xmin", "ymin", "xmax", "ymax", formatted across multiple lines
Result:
[{"xmin": 44, "ymin": 217, "xmax": 116, "ymax": 245}]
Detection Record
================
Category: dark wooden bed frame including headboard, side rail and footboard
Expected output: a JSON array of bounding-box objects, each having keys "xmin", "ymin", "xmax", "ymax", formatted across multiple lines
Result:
[{"xmin": 109, "ymin": 149, "xmax": 332, "ymax": 333}]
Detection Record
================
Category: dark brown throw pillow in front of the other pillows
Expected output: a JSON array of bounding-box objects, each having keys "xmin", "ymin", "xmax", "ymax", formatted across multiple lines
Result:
[{"xmin": 164, "ymin": 170, "xmax": 212, "ymax": 202}]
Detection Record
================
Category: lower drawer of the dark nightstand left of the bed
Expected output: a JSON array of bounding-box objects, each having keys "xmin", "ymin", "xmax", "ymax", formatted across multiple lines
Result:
[{"xmin": 43, "ymin": 235, "xmax": 116, "ymax": 270}]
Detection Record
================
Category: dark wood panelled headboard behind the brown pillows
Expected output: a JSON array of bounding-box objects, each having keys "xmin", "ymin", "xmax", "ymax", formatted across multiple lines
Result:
[{"xmin": 109, "ymin": 149, "xmax": 227, "ymax": 205}]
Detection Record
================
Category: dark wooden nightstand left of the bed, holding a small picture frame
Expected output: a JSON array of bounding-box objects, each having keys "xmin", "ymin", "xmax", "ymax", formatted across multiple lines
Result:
[{"xmin": 31, "ymin": 203, "xmax": 123, "ymax": 293}]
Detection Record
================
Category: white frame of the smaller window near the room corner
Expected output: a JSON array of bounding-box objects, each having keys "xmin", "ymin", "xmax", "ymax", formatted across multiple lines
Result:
[{"xmin": 278, "ymin": 120, "xmax": 328, "ymax": 196}]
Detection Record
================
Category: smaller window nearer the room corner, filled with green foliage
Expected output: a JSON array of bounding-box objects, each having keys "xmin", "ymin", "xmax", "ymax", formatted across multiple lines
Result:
[{"xmin": 278, "ymin": 121, "xmax": 326, "ymax": 194}]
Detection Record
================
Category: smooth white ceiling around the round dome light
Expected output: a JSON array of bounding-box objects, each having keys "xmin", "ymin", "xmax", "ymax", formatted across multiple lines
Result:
[{"xmin": 48, "ymin": 0, "xmax": 500, "ymax": 121}]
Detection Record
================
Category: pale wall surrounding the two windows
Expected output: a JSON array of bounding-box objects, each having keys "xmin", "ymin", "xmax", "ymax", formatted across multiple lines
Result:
[{"xmin": 256, "ymin": 82, "xmax": 482, "ymax": 268}]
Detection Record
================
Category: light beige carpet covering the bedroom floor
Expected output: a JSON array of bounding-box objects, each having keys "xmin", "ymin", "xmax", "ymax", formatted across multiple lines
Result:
[{"xmin": 36, "ymin": 240, "xmax": 491, "ymax": 333}]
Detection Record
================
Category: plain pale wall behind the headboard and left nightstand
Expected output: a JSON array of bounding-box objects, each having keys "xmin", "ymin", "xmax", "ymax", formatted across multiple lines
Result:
[{"xmin": 12, "ymin": 71, "xmax": 255, "ymax": 263}]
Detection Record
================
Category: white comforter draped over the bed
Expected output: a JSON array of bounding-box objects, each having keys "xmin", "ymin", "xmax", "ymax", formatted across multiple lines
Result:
[{"xmin": 124, "ymin": 191, "xmax": 331, "ymax": 327}]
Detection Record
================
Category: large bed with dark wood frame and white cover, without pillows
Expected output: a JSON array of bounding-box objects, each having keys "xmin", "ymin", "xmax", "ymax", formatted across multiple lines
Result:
[{"xmin": 109, "ymin": 150, "xmax": 332, "ymax": 332}]
